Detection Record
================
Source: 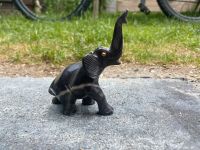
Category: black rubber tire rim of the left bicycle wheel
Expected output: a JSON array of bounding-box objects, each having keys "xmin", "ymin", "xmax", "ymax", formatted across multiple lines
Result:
[{"xmin": 14, "ymin": 0, "xmax": 91, "ymax": 21}]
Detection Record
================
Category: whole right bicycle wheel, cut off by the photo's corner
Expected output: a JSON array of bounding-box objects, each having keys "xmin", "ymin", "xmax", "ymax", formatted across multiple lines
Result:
[{"xmin": 157, "ymin": 0, "xmax": 200, "ymax": 22}]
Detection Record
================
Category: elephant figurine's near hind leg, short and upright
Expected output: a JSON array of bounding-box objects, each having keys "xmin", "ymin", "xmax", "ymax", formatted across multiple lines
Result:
[{"xmin": 61, "ymin": 94, "xmax": 77, "ymax": 116}]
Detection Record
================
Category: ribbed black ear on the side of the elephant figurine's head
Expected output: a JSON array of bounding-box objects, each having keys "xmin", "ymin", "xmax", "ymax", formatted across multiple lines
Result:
[{"xmin": 82, "ymin": 54, "xmax": 101, "ymax": 79}]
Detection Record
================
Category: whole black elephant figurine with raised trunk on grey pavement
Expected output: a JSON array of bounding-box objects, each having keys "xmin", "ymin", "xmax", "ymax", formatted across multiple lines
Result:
[{"xmin": 49, "ymin": 11, "xmax": 128, "ymax": 116}]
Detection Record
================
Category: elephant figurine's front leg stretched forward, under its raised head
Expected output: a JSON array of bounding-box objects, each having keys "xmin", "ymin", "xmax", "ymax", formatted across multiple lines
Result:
[{"xmin": 86, "ymin": 87, "xmax": 114, "ymax": 116}]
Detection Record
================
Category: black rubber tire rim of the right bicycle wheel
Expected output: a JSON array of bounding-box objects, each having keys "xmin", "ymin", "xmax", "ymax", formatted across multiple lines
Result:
[{"xmin": 157, "ymin": 0, "xmax": 200, "ymax": 22}]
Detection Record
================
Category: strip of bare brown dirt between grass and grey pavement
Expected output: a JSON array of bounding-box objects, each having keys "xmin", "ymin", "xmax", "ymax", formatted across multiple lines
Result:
[{"xmin": 0, "ymin": 62, "xmax": 200, "ymax": 82}]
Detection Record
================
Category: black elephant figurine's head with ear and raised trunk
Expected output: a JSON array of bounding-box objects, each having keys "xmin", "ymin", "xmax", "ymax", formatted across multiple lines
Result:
[{"xmin": 82, "ymin": 11, "xmax": 128, "ymax": 78}]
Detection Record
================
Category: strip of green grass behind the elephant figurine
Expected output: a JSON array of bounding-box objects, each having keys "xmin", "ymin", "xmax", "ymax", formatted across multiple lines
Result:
[{"xmin": 0, "ymin": 13, "xmax": 200, "ymax": 66}]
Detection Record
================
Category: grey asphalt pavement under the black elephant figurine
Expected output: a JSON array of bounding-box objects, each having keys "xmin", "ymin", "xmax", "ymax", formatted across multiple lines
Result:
[{"xmin": 0, "ymin": 77, "xmax": 200, "ymax": 150}]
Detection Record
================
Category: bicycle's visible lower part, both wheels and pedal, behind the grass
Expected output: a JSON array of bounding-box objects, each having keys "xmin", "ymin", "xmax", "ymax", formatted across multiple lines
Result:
[{"xmin": 0, "ymin": 0, "xmax": 200, "ymax": 22}]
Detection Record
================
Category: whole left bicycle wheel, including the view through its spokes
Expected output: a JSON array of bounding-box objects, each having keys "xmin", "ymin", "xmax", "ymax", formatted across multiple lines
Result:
[{"xmin": 14, "ymin": 0, "xmax": 91, "ymax": 21}]
